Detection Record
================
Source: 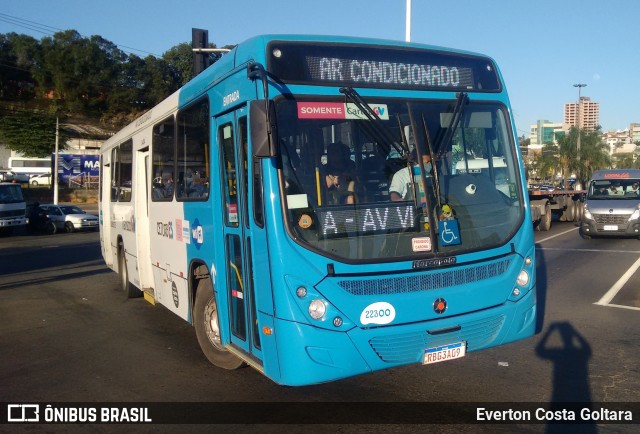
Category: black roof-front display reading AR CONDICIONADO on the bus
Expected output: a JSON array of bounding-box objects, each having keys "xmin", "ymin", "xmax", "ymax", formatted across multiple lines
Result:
[{"xmin": 269, "ymin": 42, "xmax": 500, "ymax": 92}]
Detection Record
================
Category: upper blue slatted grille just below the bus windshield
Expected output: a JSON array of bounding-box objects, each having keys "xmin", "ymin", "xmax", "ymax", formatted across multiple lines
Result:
[{"xmin": 338, "ymin": 259, "xmax": 511, "ymax": 295}]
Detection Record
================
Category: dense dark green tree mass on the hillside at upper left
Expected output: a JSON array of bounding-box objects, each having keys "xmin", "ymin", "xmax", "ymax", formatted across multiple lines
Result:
[{"xmin": 0, "ymin": 30, "xmax": 230, "ymax": 156}]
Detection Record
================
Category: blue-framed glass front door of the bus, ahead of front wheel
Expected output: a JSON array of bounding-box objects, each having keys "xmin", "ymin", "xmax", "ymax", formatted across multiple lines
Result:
[{"xmin": 214, "ymin": 107, "xmax": 262, "ymax": 363}]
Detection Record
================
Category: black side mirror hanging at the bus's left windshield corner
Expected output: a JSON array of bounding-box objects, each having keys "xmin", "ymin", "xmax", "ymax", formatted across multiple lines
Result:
[{"xmin": 249, "ymin": 99, "xmax": 278, "ymax": 158}]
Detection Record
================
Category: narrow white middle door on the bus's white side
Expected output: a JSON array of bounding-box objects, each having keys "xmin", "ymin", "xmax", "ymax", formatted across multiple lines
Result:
[{"xmin": 133, "ymin": 146, "xmax": 154, "ymax": 291}]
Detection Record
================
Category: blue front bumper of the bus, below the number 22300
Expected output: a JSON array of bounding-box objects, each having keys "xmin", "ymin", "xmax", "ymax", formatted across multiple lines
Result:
[{"xmin": 265, "ymin": 285, "xmax": 536, "ymax": 386}]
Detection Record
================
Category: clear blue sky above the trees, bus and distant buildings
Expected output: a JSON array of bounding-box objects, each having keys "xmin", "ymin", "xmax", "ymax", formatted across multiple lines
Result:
[{"xmin": 0, "ymin": 0, "xmax": 640, "ymax": 137}]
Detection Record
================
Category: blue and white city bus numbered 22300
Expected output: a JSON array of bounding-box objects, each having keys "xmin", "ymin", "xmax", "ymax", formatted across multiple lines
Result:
[{"xmin": 100, "ymin": 35, "xmax": 536, "ymax": 385}]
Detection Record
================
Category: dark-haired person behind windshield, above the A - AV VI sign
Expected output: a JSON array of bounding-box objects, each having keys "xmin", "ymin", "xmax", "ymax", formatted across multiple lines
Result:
[{"xmin": 323, "ymin": 142, "xmax": 356, "ymax": 205}]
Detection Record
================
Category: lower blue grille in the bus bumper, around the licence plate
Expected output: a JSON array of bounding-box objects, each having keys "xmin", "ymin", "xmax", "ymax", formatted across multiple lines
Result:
[{"xmin": 369, "ymin": 315, "xmax": 505, "ymax": 363}]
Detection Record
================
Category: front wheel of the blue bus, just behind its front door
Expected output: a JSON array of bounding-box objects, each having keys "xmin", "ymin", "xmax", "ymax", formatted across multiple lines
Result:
[{"xmin": 193, "ymin": 279, "xmax": 244, "ymax": 370}]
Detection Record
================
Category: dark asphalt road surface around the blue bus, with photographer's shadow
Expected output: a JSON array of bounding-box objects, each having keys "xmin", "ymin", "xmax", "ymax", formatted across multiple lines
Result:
[{"xmin": 0, "ymin": 223, "xmax": 640, "ymax": 433}]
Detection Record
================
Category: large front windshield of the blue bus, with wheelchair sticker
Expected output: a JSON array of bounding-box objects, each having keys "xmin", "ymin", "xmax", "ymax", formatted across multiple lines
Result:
[{"xmin": 277, "ymin": 98, "xmax": 524, "ymax": 262}]
